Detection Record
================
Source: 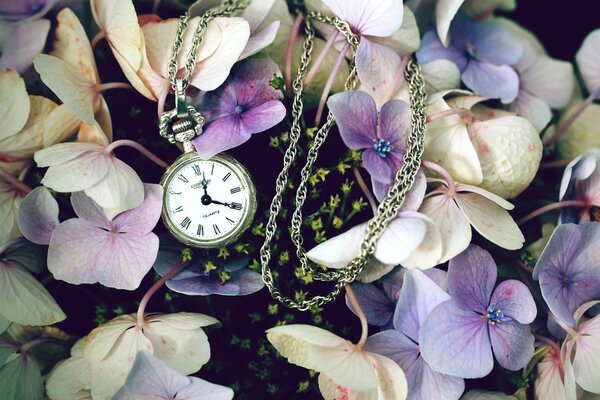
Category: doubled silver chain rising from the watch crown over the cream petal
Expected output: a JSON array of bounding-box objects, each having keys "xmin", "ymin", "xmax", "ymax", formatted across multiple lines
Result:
[{"xmin": 168, "ymin": 0, "xmax": 247, "ymax": 90}]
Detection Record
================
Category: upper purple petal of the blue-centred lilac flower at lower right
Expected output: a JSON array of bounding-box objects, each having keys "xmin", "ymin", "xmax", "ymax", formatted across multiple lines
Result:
[{"xmin": 448, "ymin": 245, "xmax": 498, "ymax": 314}]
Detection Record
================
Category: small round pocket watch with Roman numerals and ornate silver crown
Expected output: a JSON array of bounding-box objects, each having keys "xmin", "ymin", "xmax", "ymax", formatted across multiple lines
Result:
[{"xmin": 160, "ymin": 78, "xmax": 256, "ymax": 248}]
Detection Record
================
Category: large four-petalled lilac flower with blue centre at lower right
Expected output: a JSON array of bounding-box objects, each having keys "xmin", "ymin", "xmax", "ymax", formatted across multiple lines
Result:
[{"xmin": 419, "ymin": 245, "xmax": 537, "ymax": 378}]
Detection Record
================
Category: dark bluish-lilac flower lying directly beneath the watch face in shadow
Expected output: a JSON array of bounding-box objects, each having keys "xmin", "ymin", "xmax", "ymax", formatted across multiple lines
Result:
[{"xmin": 154, "ymin": 251, "xmax": 265, "ymax": 296}]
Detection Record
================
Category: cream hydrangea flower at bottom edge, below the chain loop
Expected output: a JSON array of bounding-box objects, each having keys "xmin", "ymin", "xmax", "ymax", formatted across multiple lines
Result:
[{"xmin": 267, "ymin": 324, "xmax": 407, "ymax": 400}]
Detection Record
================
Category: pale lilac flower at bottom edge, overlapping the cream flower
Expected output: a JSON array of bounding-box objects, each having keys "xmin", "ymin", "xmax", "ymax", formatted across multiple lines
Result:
[{"xmin": 113, "ymin": 351, "xmax": 233, "ymax": 400}]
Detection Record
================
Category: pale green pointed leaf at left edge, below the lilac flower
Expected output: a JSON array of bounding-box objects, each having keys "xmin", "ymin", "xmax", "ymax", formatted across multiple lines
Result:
[{"xmin": 0, "ymin": 263, "xmax": 66, "ymax": 326}]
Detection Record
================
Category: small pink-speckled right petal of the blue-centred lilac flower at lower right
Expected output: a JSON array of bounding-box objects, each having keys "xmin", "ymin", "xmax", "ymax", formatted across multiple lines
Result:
[{"xmin": 490, "ymin": 279, "xmax": 537, "ymax": 324}]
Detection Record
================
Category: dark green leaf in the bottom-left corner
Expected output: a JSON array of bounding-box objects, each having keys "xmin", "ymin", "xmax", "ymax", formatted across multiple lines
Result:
[{"xmin": 0, "ymin": 354, "xmax": 44, "ymax": 400}]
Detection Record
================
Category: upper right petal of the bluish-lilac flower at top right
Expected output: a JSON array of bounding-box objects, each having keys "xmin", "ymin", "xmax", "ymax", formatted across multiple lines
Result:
[{"xmin": 473, "ymin": 22, "xmax": 523, "ymax": 65}]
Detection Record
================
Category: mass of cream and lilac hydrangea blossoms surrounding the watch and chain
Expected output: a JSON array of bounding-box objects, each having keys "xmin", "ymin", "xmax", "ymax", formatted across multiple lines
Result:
[{"xmin": 0, "ymin": 0, "xmax": 600, "ymax": 400}]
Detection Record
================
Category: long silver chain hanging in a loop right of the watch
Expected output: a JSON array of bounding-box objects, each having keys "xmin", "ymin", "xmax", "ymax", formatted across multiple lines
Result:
[{"xmin": 260, "ymin": 12, "xmax": 427, "ymax": 311}]
